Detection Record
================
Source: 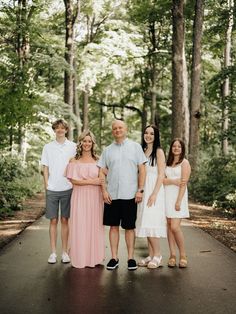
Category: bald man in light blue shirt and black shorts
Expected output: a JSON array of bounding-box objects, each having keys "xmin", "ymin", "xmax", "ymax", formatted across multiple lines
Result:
[{"xmin": 98, "ymin": 120, "xmax": 147, "ymax": 270}]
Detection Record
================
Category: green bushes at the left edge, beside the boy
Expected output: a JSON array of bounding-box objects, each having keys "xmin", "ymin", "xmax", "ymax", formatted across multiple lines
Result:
[{"xmin": 0, "ymin": 157, "xmax": 42, "ymax": 215}]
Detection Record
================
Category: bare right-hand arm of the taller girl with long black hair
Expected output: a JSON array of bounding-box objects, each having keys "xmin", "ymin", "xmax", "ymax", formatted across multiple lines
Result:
[{"xmin": 147, "ymin": 149, "xmax": 165, "ymax": 207}]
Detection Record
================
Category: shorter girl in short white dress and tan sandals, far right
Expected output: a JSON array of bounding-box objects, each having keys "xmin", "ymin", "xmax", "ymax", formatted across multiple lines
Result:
[{"xmin": 164, "ymin": 138, "xmax": 191, "ymax": 268}]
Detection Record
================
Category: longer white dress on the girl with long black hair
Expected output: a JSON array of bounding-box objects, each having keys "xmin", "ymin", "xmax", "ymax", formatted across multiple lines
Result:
[{"xmin": 136, "ymin": 164, "xmax": 166, "ymax": 238}]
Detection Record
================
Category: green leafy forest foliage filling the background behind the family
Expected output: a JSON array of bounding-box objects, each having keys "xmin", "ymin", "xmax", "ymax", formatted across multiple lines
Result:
[{"xmin": 0, "ymin": 0, "xmax": 236, "ymax": 216}]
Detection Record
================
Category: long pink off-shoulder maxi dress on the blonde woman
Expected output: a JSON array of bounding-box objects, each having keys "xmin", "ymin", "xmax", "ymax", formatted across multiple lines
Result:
[{"xmin": 66, "ymin": 161, "xmax": 105, "ymax": 268}]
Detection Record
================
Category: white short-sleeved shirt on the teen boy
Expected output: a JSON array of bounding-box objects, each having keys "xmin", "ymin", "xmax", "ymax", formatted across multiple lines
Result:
[{"xmin": 41, "ymin": 139, "xmax": 76, "ymax": 191}]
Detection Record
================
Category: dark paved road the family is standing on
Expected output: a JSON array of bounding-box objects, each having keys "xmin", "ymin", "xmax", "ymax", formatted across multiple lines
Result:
[{"xmin": 0, "ymin": 218, "xmax": 236, "ymax": 314}]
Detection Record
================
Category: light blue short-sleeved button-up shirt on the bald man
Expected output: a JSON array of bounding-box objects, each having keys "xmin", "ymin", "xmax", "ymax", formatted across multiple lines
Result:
[{"xmin": 98, "ymin": 139, "xmax": 147, "ymax": 200}]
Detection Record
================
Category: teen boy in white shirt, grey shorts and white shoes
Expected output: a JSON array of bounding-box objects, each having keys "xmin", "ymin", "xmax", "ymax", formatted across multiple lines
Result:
[{"xmin": 41, "ymin": 119, "xmax": 76, "ymax": 264}]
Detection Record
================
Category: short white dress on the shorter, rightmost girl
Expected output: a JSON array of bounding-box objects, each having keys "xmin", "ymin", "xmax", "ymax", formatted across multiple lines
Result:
[{"xmin": 165, "ymin": 164, "xmax": 189, "ymax": 218}]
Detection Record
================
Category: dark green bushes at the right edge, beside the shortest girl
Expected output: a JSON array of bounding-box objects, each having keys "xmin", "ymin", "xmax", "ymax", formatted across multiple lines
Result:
[{"xmin": 189, "ymin": 155, "xmax": 236, "ymax": 216}]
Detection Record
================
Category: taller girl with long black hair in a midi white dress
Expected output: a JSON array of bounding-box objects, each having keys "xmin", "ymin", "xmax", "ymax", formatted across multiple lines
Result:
[{"xmin": 136, "ymin": 125, "xmax": 167, "ymax": 268}]
